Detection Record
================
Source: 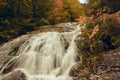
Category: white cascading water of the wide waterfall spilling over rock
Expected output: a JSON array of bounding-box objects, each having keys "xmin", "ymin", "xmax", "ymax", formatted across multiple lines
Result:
[{"xmin": 1, "ymin": 22, "xmax": 80, "ymax": 80}]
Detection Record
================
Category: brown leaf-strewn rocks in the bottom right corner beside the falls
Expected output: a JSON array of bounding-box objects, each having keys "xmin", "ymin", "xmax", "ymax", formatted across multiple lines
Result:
[{"xmin": 70, "ymin": 51, "xmax": 120, "ymax": 80}]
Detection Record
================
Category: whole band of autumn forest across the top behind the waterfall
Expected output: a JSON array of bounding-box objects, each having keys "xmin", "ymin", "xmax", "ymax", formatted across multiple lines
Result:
[{"xmin": 0, "ymin": 0, "xmax": 120, "ymax": 43}]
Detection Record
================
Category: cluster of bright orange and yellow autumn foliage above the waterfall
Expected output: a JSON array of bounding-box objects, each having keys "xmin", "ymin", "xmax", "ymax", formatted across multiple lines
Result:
[{"xmin": 49, "ymin": 0, "xmax": 84, "ymax": 23}]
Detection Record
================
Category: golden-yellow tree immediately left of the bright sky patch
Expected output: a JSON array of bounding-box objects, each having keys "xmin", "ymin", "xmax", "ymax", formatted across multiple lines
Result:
[{"xmin": 63, "ymin": 0, "xmax": 84, "ymax": 21}]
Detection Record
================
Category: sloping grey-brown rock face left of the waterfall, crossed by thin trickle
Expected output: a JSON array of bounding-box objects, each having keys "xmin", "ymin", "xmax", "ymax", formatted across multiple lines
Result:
[{"xmin": 0, "ymin": 35, "xmax": 29, "ymax": 73}]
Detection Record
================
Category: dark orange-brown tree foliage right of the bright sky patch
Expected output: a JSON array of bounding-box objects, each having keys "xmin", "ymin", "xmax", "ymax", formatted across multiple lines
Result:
[{"xmin": 85, "ymin": 0, "xmax": 120, "ymax": 16}]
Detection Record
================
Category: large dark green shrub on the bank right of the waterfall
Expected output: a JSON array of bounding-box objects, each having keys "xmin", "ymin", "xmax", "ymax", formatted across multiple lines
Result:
[{"xmin": 79, "ymin": 17, "xmax": 120, "ymax": 54}]
